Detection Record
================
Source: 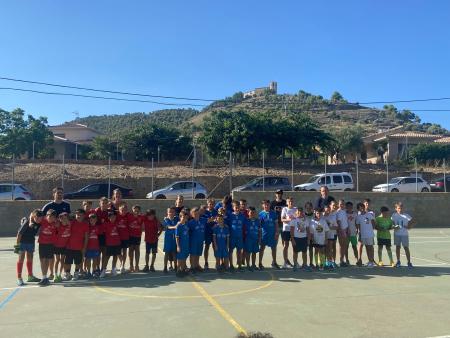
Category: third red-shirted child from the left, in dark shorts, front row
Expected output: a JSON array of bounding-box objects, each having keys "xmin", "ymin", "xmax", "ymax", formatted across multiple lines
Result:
[{"xmin": 64, "ymin": 209, "xmax": 89, "ymax": 280}]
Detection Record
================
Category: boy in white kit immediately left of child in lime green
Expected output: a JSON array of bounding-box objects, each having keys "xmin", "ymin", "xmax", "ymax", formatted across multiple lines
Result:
[{"xmin": 356, "ymin": 203, "xmax": 375, "ymax": 268}]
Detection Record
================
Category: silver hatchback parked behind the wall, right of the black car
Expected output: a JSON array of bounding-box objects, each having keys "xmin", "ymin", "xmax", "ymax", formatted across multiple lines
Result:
[{"xmin": 146, "ymin": 181, "xmax": 208, "ymax": 199}]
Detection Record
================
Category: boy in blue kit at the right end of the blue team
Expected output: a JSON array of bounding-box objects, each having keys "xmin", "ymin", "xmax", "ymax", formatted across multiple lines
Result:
[{"xmin": 259, "ymin": 200, "xmax": 280, "ymax": 270}]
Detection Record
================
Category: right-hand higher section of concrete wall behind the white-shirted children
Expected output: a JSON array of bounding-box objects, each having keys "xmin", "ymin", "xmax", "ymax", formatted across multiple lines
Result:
[{"xmin": 233, "ymin": 192, "xmax": 450, "ymax": 227}]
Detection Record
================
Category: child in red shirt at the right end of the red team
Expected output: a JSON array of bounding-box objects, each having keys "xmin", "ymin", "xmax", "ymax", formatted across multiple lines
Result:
[{"xmin": 142, "ymin": 209, "xmax": 162, "ymax": 272}]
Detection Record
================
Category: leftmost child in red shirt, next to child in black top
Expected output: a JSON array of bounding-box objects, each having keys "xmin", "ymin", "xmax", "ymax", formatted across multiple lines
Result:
[{"xmin": 38, "ymin": 209, "xmax": 57, "ymax": 286}]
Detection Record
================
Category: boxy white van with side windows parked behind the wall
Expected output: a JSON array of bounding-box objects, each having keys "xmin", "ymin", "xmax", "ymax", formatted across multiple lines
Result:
[{"xmin": 294, "ymin": 172, "xmax": 354, "ymax": 191}]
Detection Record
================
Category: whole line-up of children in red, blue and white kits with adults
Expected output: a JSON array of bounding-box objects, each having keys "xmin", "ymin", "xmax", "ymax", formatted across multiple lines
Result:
[{"xmin": 15, "ymin": 193, "xmax": 414, "ymax": 286}]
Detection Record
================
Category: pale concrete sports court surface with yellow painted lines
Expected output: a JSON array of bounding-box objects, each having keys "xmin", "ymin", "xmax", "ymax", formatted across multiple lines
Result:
[{"xmin": 0, "ymin": 229, "xmax": 450, "ymax": 337}]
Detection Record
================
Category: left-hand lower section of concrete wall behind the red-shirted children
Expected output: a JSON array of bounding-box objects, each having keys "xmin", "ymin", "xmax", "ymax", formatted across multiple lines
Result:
[{"xmin": 0, "ymin": 200, "xmax": 206, "ymax": 236}]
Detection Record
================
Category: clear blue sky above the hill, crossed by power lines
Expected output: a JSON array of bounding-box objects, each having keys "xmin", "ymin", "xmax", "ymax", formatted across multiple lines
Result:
[{"xmin": 0, "ymin": 0, "xmax": 450, "ymax": 129}]
